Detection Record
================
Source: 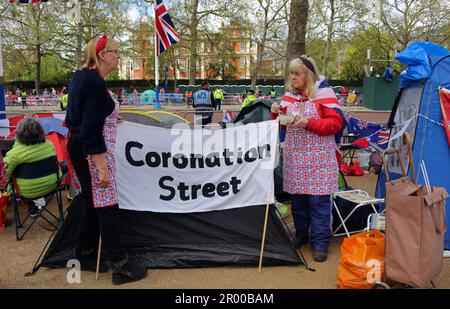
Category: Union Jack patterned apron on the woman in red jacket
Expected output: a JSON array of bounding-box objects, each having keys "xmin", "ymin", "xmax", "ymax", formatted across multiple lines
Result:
[{"xmin": 283, "ymin": 100, "xmax": 338, "ymax": 195}]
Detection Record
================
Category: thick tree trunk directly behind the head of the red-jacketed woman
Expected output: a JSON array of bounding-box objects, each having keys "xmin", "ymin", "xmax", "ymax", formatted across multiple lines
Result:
[{"xmin": 286, "ymin": 0, "xmax": 309, "ymax": 76}]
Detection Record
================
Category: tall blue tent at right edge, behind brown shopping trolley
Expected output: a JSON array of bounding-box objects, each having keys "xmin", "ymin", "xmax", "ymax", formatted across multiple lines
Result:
[{"xmin": 376, "ymin": 42, "xmax": 450, "ymax": 249}]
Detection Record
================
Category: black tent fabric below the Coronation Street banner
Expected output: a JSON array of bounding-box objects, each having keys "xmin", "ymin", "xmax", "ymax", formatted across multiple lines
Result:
[{"xmin": 41, "ymin": 196, "xmax": 302, "ymax": 268}]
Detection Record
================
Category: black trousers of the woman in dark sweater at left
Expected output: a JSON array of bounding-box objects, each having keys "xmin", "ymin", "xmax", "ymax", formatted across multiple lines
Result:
[{"xmin": 67, "ymin": 137, "xmax": 126, "ymax": 262}]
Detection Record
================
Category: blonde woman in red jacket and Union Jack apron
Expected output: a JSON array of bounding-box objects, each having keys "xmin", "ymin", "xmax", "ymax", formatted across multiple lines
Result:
[{"xmin": 271, "ymin": 56, "xmax": 343, "ymax": 262}]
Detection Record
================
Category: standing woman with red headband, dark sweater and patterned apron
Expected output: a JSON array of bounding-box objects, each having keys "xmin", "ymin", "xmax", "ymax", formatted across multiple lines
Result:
[{"xmin": 65, "ymin": 34, "xmax": 147, "ymax": 284}]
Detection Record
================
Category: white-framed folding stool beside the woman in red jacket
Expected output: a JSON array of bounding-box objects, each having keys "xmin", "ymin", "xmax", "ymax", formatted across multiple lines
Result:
[{"xmin": 333, "ymin": 190, "xmax": 384, "ymax": 236}]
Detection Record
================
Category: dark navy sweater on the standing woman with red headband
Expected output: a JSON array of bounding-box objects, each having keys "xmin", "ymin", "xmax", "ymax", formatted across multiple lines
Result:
[{"xmin": 65, "ymin": 68, "xmax": 114, "ymax": 154}]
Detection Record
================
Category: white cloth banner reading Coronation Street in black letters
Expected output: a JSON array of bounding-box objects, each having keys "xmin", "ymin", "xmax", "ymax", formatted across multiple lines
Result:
[{"xmin": 116, "ymin": 121, "xmax": 278, "ymax": 213}]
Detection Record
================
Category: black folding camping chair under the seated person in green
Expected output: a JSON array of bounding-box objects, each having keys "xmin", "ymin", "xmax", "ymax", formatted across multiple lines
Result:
[{"xmin": 11, "ymin": 156, "xmax": 67, "ymax": 241}]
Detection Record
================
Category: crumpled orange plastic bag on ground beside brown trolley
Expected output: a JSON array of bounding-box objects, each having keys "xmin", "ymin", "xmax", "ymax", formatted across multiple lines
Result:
[{"xmin": 337, "ymin": 230, "xmax": 385, "ymax": 289}]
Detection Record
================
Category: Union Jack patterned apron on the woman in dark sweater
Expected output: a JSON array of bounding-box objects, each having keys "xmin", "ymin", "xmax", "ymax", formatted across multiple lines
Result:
[{"xmin": 87, "ymin": 100, "xmax": 119, "ymax": 208}]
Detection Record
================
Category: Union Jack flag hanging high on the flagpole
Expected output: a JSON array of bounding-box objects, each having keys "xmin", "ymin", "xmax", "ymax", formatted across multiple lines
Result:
[{"xmin": 155, "ymin": 0, "xmax": 180, "ymax": 56}]
